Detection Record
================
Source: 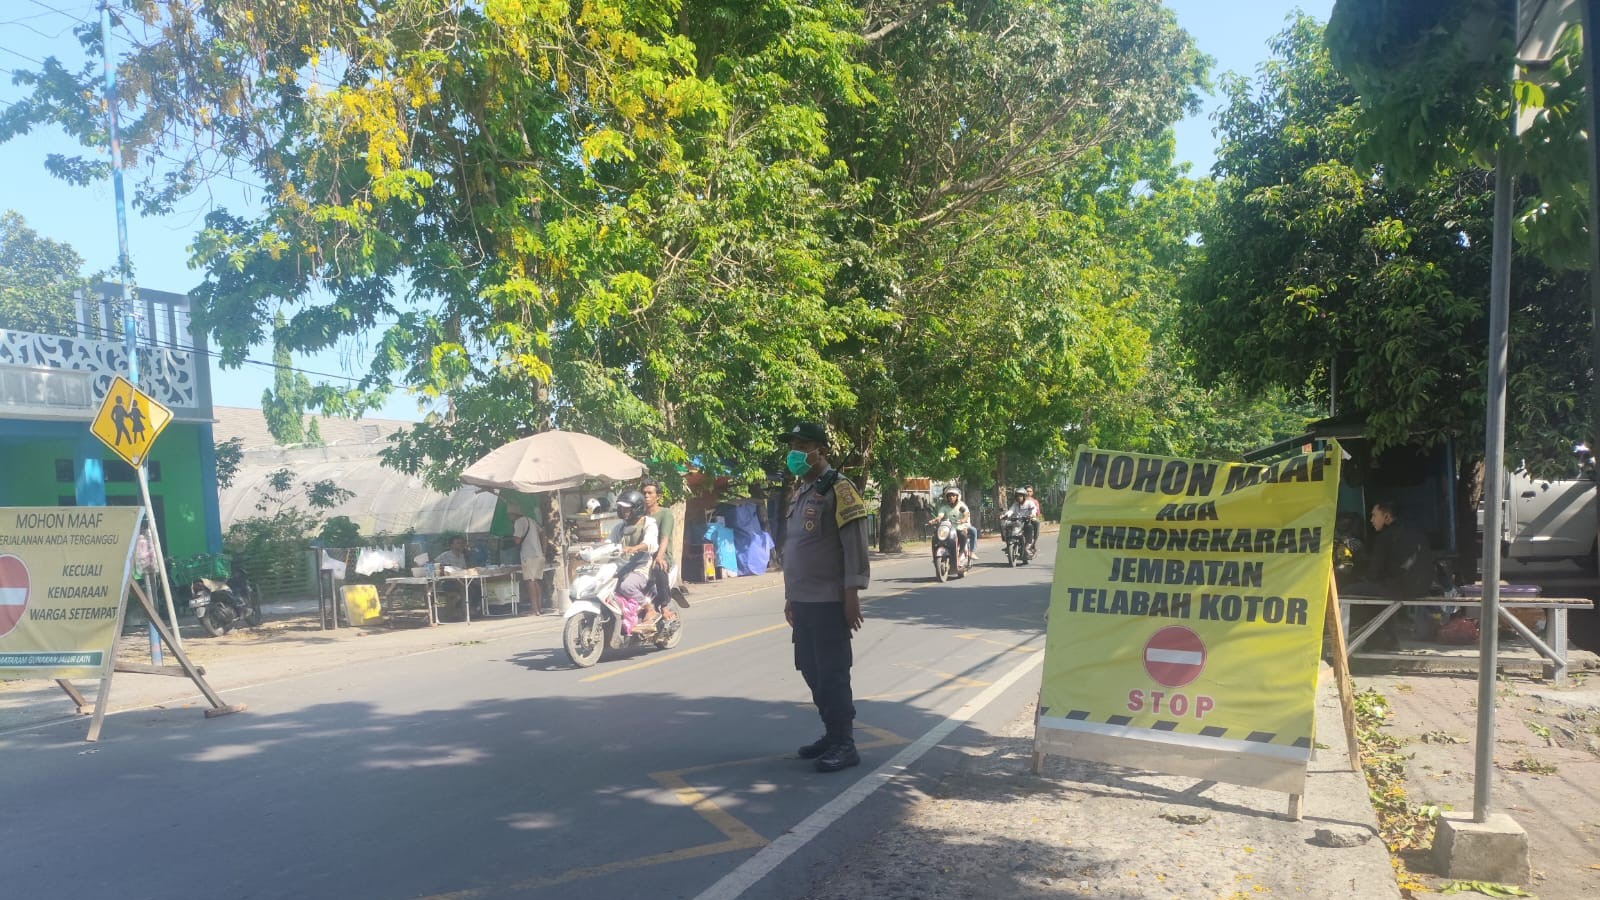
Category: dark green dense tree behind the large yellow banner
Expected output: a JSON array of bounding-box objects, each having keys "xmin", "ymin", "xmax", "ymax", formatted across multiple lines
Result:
[{"xmin": 1184, "ymin": 18, "xmax": 1586, "ymax": 470}]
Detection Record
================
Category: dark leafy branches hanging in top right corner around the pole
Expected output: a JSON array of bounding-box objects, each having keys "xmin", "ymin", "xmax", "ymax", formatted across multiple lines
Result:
[{"xmin": 1326, "ymin": 0, "xmax": 1590, "ymax": 271}]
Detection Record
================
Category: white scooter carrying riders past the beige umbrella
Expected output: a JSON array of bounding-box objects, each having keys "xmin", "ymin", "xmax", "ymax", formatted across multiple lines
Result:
[{"xmin": 562, "ymin": 543, "xmax": 688, "ymax": 669}]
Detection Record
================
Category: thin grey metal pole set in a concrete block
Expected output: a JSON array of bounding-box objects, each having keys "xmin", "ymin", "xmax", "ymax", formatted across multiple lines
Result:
[{"xmin": 1472, "ymin": 47, "xmax": 1517, "ymax": 822}]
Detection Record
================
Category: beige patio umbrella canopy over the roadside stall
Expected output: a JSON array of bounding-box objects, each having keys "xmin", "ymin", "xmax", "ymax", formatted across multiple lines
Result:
[{"xmin": 461, "ymin": 431, "xmax": 645, "ymax": 493}]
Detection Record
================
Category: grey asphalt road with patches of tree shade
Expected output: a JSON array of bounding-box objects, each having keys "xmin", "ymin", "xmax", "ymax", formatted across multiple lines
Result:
[{"xmin": 0, "ymin": 535, "xmax": 1054, "ymax": 900}]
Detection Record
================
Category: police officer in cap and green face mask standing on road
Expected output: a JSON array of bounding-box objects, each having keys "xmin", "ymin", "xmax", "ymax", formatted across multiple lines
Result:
[{"xmin": 779, "ymin": 423, "xmax": 870, "ymax": 772}]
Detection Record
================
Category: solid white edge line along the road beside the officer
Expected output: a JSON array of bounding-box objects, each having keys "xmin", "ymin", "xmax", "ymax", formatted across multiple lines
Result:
[{"xmin": 694, "ymin": 640, "xmax": 1045, "ymax": 900}]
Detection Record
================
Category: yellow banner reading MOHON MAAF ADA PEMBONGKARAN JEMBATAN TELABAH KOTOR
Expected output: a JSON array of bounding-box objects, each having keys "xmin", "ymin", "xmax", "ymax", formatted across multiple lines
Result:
[{"xmin": 1035, "ymin": 445, "xmax": 1339, "ymax": 794}]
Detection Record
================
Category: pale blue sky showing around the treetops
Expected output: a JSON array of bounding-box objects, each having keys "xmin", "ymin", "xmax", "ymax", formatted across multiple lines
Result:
[{"xmin": 0, "ymin": 0, "xmax": 1333, "ymax": 420}]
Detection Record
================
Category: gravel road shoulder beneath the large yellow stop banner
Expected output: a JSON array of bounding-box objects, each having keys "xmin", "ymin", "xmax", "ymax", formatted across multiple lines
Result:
[{"xmin": 798, "ymin": 668, "xmax": 1400, "ymax": 900}]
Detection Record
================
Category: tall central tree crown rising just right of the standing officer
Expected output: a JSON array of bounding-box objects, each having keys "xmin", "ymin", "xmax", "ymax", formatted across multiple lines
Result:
[{"xmin": 830, "ymin": 2, "xmax": 1205, "ymax": 482}]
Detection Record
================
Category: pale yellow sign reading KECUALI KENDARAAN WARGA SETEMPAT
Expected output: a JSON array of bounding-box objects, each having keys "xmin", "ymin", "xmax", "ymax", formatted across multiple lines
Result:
[{"xmin": 0, "ymin": 506, "xmax": 144, "ymax": 679}]
